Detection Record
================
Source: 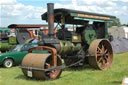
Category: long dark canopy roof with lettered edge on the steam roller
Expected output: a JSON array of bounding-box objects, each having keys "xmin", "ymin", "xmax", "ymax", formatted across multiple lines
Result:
[{"xmin": 41, "ymin": 8, "xmax": 116, "ymax": 24}]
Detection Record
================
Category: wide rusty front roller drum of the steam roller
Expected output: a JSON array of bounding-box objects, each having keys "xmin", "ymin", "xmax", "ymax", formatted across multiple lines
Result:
[{"xmin": 22, "ymin": 53, "xmax": 62, "ymax": 80}]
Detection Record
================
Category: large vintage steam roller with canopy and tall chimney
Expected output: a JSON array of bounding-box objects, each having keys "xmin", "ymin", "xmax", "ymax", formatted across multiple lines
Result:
[{"xmin": 21, "ymin": 3, "xmax": 116, "ymax": 80}]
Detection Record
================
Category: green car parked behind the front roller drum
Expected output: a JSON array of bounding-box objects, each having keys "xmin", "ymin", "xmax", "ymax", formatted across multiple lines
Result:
[{"xmin": 0, "ymin": 43, "xmax": 37, "ymax": 68}]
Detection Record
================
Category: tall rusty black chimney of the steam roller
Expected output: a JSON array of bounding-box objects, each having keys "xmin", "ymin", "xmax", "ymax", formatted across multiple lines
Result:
[{"xmin": 47, "ymin": 3, "xmax": 54, "ymax": 39}]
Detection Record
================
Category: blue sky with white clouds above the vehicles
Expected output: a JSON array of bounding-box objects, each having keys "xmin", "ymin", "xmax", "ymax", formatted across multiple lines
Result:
[{"xmin": 0, "ymin": 0, "xmax": 128, "ymax": 27}]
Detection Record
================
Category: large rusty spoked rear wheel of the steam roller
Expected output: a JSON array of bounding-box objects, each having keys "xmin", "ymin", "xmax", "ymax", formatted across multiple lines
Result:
[{"xmin": 88, "ymin": 39, "xmax": 113, "ymax": 70}]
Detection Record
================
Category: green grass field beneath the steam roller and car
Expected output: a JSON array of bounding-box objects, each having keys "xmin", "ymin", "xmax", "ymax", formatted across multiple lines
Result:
[{"xmin": 0, "ymin": 53, "xmax": 128, "ymax": 85}]
